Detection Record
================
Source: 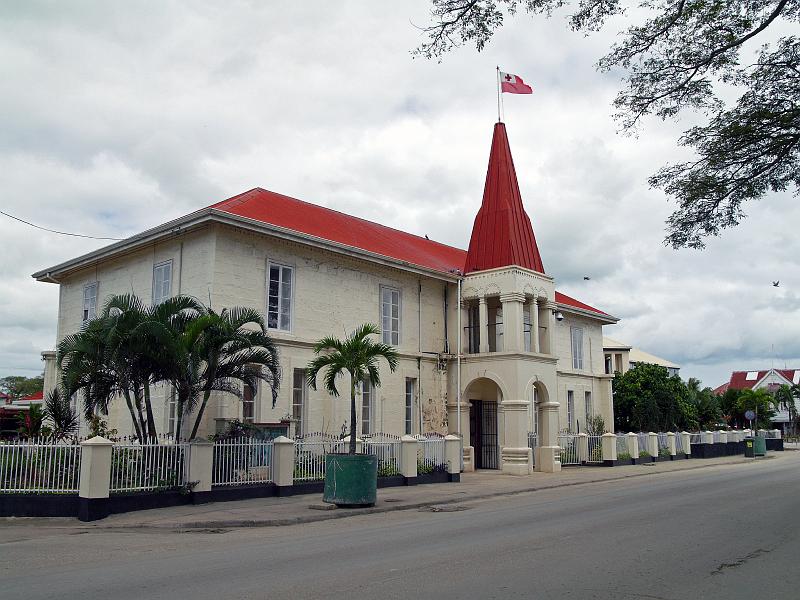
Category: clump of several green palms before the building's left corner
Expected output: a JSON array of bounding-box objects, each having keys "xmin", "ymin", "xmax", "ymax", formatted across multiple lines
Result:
[{"xmin": 57, "ymin": 294, "xmax": 280, "ymax": 440}]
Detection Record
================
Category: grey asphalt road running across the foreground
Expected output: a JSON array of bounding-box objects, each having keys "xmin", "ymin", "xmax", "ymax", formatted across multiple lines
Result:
[{"xmin": 0, "ymin": 452, "xmax": 800, "ymax": 600}]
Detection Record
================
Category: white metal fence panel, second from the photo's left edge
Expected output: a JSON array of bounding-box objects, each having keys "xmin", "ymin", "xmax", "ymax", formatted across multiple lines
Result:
[{"xmin": 110, "ymin": 443, "xmax": 189, "ymax": 494}]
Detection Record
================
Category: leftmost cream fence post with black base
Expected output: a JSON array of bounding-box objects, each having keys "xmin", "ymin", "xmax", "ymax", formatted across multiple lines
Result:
[{"xmin": 78, "ymin": 436, "xmax": 114, "ymax": 521}]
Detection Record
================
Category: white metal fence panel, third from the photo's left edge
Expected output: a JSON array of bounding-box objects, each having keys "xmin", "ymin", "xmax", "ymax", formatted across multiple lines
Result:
[{"xmin": 211, "ymin": 437, "xmax": 274, "ymax": 486}]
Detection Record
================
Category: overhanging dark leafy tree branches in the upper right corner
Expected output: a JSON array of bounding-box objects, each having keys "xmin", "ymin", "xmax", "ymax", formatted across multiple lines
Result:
[{"xmin": 414, "ymin": 0, "xmax": 800, "ymax": 248}]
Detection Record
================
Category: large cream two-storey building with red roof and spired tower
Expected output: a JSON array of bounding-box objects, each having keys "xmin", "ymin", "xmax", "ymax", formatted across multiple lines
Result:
[{"xmin": 34, "ymin": 123, "xmax": 617, "ymax": 473}]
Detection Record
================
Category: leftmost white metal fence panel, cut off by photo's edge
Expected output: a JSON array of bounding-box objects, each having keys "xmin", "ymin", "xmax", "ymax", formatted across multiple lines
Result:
[{"xmin": 0, "ymin": 440, "xmax": 81, "ymax": 494}]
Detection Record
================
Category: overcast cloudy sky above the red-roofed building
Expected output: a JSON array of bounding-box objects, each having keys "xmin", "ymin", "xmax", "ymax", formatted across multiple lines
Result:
[{"xmin": 0, "ymin": 0, "xmax": 800, "ymax": 386}]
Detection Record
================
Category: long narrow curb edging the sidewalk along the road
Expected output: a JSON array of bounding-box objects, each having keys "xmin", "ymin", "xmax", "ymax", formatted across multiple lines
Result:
[{"xmin": 91, "ymin": 459, "xmax": 768, "ymax": 531}]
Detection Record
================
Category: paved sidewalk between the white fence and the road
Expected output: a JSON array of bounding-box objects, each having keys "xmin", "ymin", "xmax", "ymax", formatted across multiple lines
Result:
[{"xmin": 0, "ymin": 451, "xmax": 800, "ymax": 530}]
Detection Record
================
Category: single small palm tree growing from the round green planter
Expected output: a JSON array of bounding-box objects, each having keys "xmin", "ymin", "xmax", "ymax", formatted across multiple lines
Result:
[{"xmin": 306, "ymin": 323, "xmax": 397, "ymax": 454}]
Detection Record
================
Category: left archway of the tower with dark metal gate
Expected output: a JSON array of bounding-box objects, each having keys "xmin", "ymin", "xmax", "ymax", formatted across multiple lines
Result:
[{"xmin": 464, "ymin": 377, "xmax": 503, "ymax": 469}]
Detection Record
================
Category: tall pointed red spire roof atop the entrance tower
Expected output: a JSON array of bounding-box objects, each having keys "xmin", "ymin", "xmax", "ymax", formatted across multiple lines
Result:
[{"xmin": 464, "ymin": 123, "xmax": 544, "ymax": 273}]
